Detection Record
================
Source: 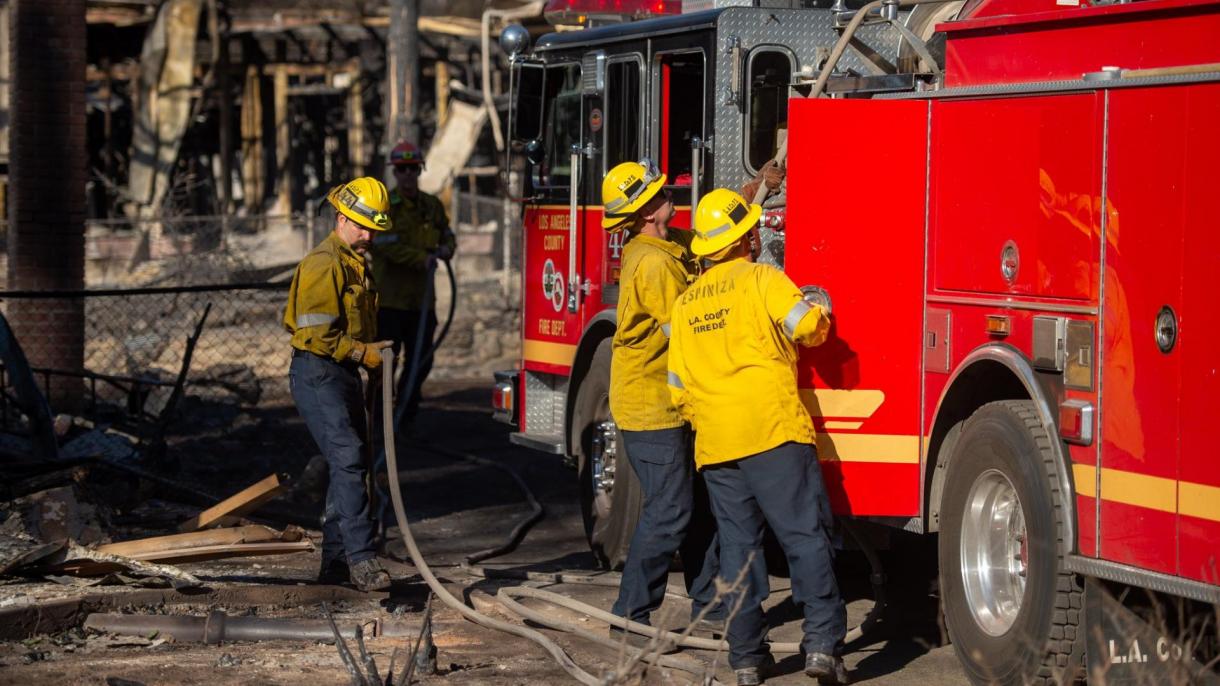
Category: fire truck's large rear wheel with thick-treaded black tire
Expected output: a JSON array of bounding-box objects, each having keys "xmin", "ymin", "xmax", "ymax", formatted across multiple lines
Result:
[{"xmin": 939, "ymin": 400, "xmax": 1083, "ymax": 685}]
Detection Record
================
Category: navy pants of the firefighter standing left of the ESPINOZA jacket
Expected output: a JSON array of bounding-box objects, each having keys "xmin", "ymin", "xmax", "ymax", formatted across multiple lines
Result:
[{"xmin": 612, "ymin": 426, "xmax": 725, "ymax": 624}]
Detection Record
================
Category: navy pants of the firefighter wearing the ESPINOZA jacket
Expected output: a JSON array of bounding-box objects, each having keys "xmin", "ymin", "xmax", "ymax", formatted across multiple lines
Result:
[{"xmin": 703, "ymin": 443, "xmax": 847, "ymax": 669}]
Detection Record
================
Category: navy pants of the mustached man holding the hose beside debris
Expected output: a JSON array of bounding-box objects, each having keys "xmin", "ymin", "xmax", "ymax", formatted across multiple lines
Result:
[{"xmin": 288, "ymin": 350, "xmax": 377, "ymax": 564}]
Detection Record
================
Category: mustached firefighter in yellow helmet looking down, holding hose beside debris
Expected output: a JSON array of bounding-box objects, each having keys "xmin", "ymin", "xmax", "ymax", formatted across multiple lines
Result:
[{"xmin": 284, "ymin": 177, "xmax": 390, "ymax": 591}]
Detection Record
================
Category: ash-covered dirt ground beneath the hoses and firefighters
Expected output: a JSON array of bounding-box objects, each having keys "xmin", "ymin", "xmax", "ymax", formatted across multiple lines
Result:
[{"xmin": 0, "ymin": 380, "xmax": 966, "ymax": 686}]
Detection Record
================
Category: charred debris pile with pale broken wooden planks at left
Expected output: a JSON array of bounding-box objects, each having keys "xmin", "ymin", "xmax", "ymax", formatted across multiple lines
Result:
[{"xmin": 0, "ymin": 305, "xmax": 316, "ymax": 588}]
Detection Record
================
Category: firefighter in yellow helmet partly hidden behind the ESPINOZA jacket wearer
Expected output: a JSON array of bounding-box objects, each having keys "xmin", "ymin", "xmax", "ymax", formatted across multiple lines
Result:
[{"xmin": 601, "ymin": 159, "xmax": 723, "ymax": 643}]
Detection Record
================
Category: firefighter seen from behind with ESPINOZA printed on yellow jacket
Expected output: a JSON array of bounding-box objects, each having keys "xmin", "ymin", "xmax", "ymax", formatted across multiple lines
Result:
[{"xmin": 669, "ymin": 188, "xmax": 847, "ymax": 686}]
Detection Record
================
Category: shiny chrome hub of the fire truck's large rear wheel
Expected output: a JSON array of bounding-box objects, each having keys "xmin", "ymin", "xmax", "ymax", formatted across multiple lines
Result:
[{"xmin": 960, "ymin": 470, "xmax": 1030, "ymax": 636}]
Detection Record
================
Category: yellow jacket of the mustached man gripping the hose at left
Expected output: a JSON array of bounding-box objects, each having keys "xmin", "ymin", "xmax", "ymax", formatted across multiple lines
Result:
[{"xmin": 284, "ymin": 232, "xmax": 377, "ymax": 363}]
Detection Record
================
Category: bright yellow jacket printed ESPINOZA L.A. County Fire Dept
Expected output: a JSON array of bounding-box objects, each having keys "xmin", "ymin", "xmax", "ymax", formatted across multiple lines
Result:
[{"xmin": 669, "ymin": 253, "xmax": 830, "ymax": 469}]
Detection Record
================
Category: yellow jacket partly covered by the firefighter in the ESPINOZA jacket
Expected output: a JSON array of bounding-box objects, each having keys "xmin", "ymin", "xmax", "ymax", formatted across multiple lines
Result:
[{"xmin": 610, "ymin": 229, "xmax": 695, "ymax": 431}]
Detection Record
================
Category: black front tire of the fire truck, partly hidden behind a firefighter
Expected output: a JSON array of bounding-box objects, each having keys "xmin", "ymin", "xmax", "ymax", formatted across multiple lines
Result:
[{"xmin": 571, "ymin": 338, "xmax": 643, "ymax": 569}]
